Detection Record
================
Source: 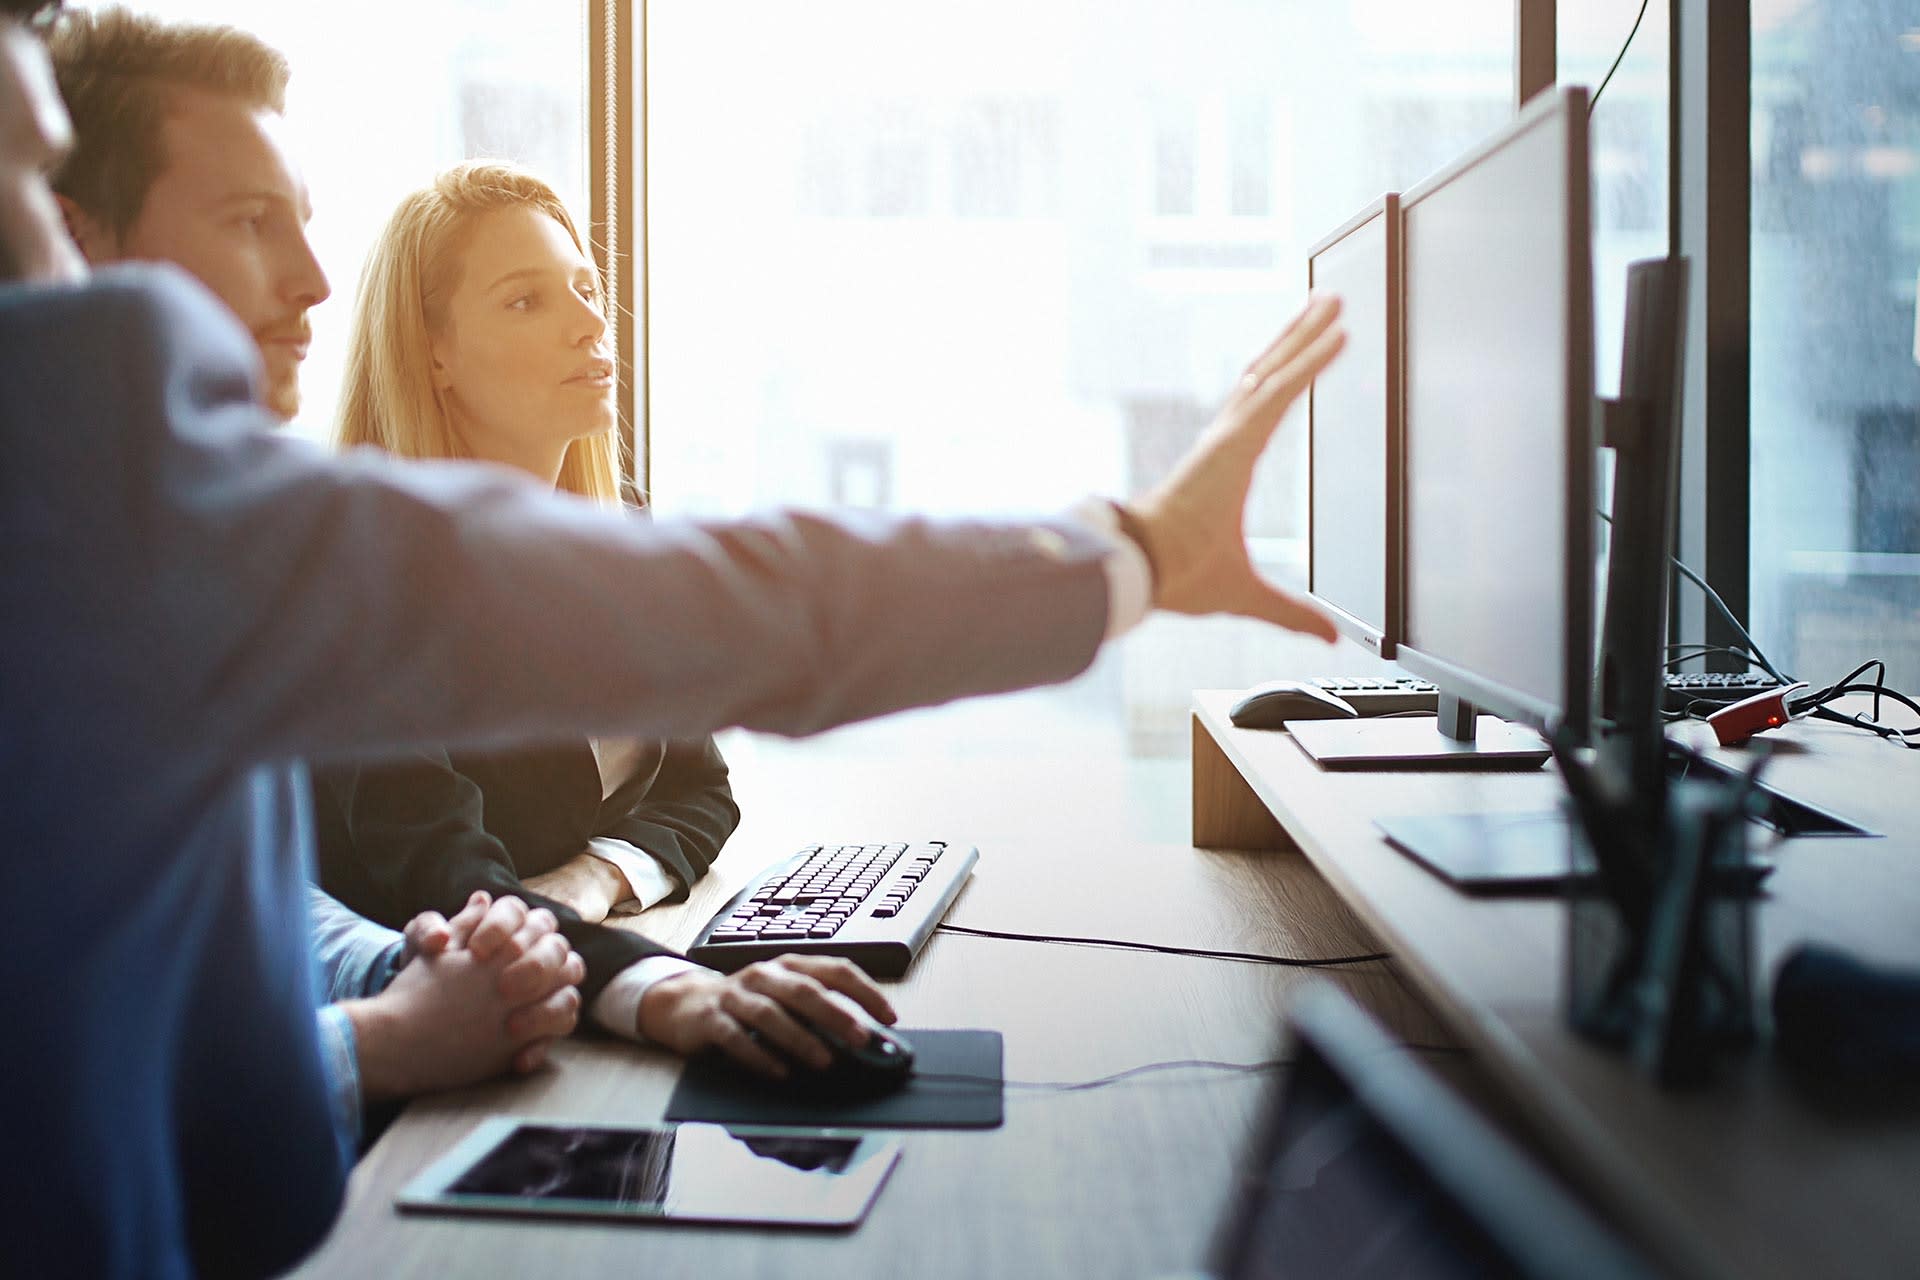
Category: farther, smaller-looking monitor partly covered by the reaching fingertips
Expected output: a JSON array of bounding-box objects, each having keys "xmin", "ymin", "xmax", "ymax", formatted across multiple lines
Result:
[{"xmin": 1308, "ymin": 194, "xmax": 1400, "ymax": 658}]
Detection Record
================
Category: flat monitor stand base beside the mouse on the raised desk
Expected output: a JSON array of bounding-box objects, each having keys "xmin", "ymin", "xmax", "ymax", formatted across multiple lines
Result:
[{"xmin": 1286, "ymin": 693, "xmax": 1549, "ymax": 771}]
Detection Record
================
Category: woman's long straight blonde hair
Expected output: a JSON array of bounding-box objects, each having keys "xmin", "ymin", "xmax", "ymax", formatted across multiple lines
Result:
[{"xmin": 334, "ymin": 161, "xmax": 620, "ymax": 503}]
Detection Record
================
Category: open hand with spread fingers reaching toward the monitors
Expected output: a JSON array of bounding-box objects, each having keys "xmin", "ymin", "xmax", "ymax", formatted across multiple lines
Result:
[{"xmin": 1125, "ymin": 297, "xmax": 1346, "ymax": 641}]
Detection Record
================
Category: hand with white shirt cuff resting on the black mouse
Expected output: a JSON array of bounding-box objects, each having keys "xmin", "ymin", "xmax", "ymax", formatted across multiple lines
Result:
[{"xmin": 639, "ymin": 956, "xmax": 895, "ymax": 1079}]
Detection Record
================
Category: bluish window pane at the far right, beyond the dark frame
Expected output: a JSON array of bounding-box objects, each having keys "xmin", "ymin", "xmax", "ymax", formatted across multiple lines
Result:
[{"xmin": 1749, "ymin": 0, "xmax": 1920, "ymax": 689}]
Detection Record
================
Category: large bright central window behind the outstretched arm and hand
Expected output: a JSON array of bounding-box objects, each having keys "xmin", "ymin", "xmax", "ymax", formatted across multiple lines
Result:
[{"xmin": 641, "ymin": 0, "xmax": 1512, "ymax": 754}]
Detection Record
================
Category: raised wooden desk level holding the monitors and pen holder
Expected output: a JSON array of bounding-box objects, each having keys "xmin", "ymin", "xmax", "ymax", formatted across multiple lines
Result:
[{"xmin": 1194, "ymin": 693, "xmax": 1920, "ymax": 1276}]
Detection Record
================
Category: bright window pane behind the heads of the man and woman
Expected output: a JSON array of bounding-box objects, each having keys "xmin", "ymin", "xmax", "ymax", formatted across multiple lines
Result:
[{"xmin": 75, "ymin": 0, "xmax": 588, "ymax": 449}]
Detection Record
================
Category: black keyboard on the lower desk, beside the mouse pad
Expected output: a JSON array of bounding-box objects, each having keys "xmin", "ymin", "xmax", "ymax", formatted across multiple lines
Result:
[{"xmin": 687, "ymin": 841, "xmax": 979, "ymax": 979}]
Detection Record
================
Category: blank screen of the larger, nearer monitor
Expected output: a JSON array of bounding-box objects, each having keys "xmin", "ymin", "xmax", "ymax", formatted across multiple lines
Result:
[{"xmin": 1398, "ymin": 88, "xmax": 1594, "ymax": 731}]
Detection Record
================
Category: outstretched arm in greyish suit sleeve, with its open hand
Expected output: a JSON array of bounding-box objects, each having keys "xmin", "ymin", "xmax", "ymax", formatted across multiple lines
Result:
[{"xmin": 37, "ymin": 278, "xmax": 1340, "ymax": 775}]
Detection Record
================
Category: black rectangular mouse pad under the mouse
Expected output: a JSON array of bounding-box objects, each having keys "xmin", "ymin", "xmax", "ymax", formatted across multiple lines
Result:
[{"xmin": 666, "ymin": 1027, "xmax": 1006, "ymax": 1128}]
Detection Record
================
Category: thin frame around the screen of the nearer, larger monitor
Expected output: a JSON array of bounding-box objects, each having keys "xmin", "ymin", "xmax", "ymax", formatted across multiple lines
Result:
[{"xmin": 1394, "ymin": 86, "xmax": 1596, "ymax": 743}]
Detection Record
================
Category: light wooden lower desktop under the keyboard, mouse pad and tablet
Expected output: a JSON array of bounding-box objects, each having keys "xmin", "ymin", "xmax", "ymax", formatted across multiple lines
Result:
[{"xmin": 301, "ymin": 758, "xmax": 1444, "ymax": 1280}]
